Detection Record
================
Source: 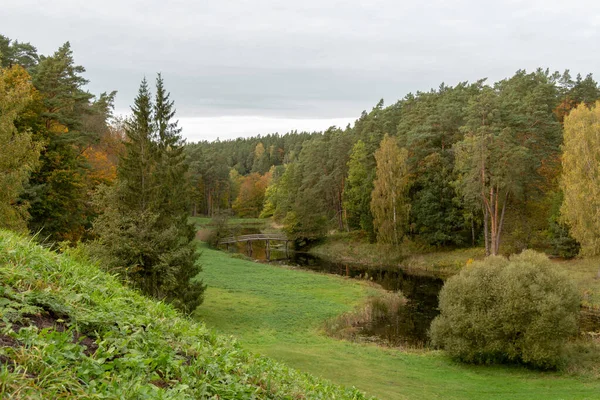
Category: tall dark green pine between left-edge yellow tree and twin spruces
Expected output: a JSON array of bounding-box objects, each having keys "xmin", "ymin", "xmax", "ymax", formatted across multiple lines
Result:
[{"xmin": 23, "ymin": 42, "xmax": 95, "ymax": 241}]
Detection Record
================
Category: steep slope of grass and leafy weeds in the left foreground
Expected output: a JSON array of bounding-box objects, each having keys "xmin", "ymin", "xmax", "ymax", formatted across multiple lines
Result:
[{"xmin": 0, "ymin": 231, "xmax": 370, "ymax": 399}]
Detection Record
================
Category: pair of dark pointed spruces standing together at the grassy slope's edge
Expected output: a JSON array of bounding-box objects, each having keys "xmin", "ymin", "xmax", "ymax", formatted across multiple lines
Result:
[{"xmin": 94, "ymin": 75, "xmax": 205, "ymax": 311}]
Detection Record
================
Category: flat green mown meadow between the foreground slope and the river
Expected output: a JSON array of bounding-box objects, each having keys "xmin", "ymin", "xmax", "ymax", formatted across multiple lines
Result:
[{"xmin": 197, "ymin": 242, "xmax": 600, "ymax": 399}]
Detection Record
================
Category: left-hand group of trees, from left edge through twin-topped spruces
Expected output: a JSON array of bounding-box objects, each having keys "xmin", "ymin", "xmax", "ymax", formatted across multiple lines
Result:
[{"xmin": 0, "ymin": 32, "xmax": 205, "ymax": 311}]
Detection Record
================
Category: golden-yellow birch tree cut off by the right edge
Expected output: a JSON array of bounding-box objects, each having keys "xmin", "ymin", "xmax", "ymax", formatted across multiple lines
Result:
[{"xmin": 561, "ymin": 101, "xmax": 600, "ymax": 255}]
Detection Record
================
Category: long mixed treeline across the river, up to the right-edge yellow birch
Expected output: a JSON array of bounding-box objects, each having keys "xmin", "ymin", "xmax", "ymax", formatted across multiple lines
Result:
[{"xmin": 188, "ymin": 69, "xmax": 600, "ymax": 256}]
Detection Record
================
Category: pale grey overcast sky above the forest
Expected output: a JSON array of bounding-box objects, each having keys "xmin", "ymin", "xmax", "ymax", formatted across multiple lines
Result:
[{"xmin": 0, "ymin": 0, "xmax": 600, "ymax": 141}]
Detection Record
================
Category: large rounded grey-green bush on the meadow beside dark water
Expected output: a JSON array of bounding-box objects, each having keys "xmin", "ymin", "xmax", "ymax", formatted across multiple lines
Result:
[{"xmin": 430, "ymin": 250, "xmax": 580, "ymax": 369}]
